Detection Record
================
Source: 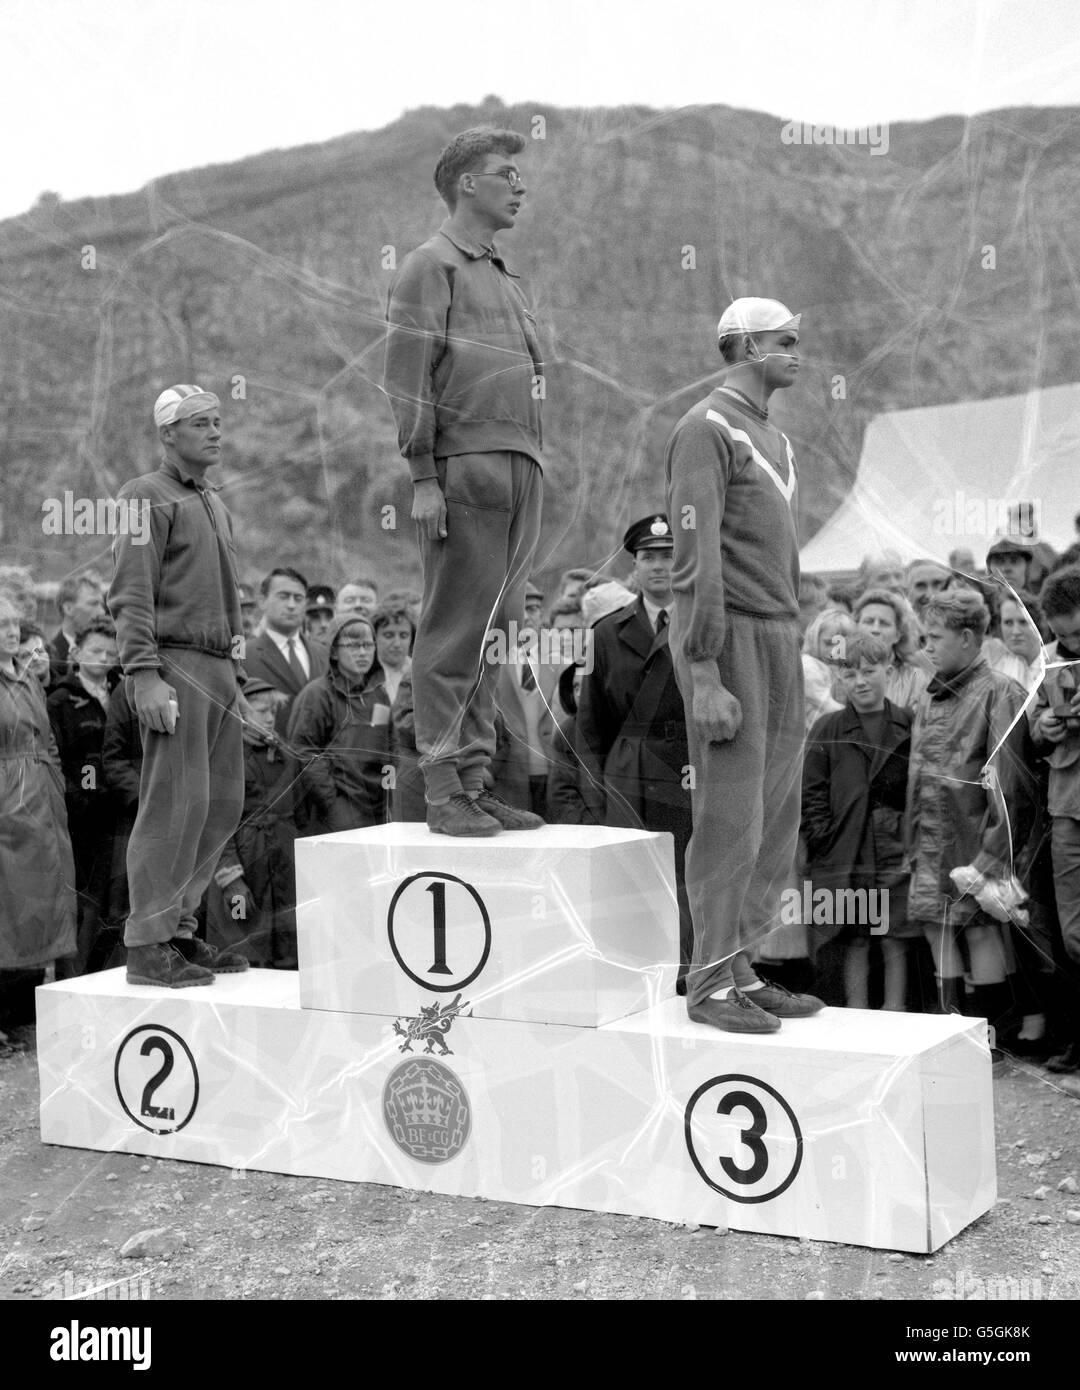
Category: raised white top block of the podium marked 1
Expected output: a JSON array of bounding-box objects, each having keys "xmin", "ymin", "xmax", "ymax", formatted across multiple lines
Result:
[{"xmin": 296, "ymin": 824, "xmax": 678, "ymax": 1027}]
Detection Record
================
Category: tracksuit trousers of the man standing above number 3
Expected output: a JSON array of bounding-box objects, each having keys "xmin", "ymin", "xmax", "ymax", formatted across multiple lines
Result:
[{"xmin": 671, "ymin": 610, "xmax": 805, "ymax": 1004}]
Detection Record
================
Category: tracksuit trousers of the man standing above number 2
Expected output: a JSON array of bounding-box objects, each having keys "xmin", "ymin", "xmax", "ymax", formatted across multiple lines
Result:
[{"xmin": 124, "ymin": 648, "xmax": 243, "ymax": 947}]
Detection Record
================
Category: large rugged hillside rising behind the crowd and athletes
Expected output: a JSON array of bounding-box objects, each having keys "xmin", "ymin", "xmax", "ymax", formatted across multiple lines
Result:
[{"xmin": 0, "ymin": 99, "xmax": 1080, "ymax": 582}]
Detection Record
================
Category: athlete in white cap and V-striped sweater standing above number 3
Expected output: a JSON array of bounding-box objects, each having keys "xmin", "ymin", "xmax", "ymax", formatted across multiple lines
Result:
[{"xmin": 666, "ymin": 299, "xmax": 823, "ymax": 1033}]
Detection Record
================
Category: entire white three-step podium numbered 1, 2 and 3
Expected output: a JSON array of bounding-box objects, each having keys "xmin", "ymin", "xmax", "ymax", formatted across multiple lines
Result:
[{"xmin": 38, "ymin": 826, "xmax": 997, "ymax": 1252}]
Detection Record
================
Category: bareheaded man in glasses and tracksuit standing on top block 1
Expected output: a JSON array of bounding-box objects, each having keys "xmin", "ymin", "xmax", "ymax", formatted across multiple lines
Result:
[{"xmin": 385, "ymin": 126, "xmax": 543, "ymax": 835}]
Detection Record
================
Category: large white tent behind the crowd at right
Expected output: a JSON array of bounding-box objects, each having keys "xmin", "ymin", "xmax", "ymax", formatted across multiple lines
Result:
[{"xmin": 801, "ymin": 384, "xmax": 1080, "ymax": 573}]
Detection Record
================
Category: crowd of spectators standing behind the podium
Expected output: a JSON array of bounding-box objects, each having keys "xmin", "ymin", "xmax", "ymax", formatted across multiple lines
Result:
[{"xmin": 0, "ymin": 517, "xmax": 1080, "ymax": 1072}]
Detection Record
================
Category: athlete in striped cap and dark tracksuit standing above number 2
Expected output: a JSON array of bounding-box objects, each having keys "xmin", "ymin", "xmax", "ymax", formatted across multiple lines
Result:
[{"xmin": 108, "ymin": 385, "xmax": 250, "ymax": 988}]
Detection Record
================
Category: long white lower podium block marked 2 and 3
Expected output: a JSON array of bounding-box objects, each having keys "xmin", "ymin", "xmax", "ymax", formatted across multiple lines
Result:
[{"xmin": 38, "ymin": 970, "xmax": 997, "ymax": 1252}]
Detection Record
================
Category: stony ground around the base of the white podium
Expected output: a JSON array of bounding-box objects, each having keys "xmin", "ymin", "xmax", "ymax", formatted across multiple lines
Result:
[{"xmin": 0, "ymin": 1029, "xmax": 1080, "ymax": 1300}]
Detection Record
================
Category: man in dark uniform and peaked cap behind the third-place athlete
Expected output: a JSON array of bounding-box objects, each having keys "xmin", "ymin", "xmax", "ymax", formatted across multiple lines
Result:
[{"xmin": 577, "ymin": 512, "xmax": 694, "ymax": 992}]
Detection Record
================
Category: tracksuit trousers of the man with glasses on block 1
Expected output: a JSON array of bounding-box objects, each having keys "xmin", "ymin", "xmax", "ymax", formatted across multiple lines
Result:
[{"xmin": 413, "ymin": 452, "xmax": 543, "ymax": 801}]
